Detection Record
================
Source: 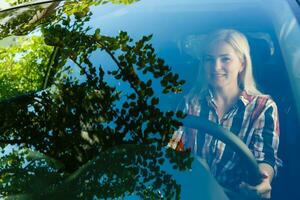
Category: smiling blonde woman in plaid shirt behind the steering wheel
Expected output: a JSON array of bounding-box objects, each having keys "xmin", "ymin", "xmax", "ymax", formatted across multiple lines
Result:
[{"xmin": 169, "ymin": 29, "xmax": 280, "ymax": 198}]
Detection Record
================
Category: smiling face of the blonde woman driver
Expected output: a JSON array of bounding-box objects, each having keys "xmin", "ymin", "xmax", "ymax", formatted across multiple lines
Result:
[{"xmin": 203, "ymin": 41, "xmax": 243, "ymax": 89}]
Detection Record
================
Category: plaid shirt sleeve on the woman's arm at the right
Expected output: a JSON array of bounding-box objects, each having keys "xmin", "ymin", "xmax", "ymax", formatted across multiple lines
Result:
[{"xmin": 252, "ymin": 99, "xmax": 282, "ymax": 175}]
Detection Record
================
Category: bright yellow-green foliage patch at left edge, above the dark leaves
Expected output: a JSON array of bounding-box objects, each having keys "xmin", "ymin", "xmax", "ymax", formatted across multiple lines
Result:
[{"xmin": 0, "ymin": 36, "xmax": 53, "ymax": 98}]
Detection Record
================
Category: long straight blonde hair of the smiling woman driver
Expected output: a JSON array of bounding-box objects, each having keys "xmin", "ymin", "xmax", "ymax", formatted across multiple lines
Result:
[{"xmin": 187, "ymin": 29, "xmax": 261, "ymax": 104}]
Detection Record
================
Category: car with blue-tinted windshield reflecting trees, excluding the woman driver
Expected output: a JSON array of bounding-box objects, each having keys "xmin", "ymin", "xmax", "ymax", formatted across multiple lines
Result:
[{"xmin": 0, "ymin": 0, "xmax": 300, "ymax": 200}]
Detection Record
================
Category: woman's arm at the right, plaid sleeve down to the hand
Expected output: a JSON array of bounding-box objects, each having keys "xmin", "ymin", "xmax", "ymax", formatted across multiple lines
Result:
[{"xmin": 240, "ymin": 99, "xmax": 279, "ymax": 199}]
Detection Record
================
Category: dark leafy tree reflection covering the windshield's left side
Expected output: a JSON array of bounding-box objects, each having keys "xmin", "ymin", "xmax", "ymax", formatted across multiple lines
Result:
[{"xmin": 0, "ymin": 0, "xmax": 192, "ymax": 199}]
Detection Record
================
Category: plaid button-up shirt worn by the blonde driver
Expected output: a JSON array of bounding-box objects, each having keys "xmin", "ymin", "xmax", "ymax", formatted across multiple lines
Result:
[{"xmin": 168, "ymin": 91, "xmax": 281, "ymax": 189}]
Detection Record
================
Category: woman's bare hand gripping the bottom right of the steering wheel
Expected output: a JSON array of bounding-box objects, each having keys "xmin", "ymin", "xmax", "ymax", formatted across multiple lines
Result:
[{"xmin": 240, "ymin": 163, "xmax": 274, "ymax": 199}]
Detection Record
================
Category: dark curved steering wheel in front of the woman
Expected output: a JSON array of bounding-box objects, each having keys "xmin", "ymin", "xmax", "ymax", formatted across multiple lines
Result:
[{"xmin": 183, "ymin": 115, "xmax": 261, "ymax": 185}]
